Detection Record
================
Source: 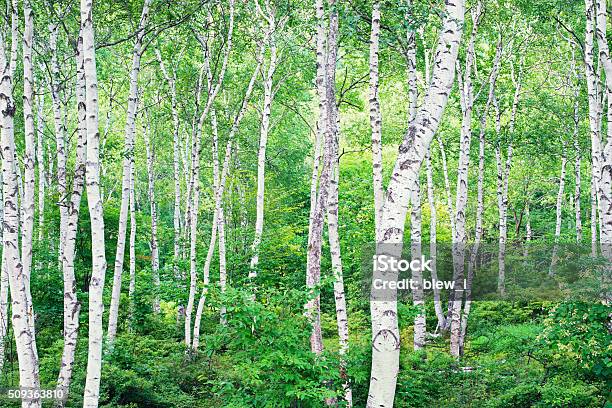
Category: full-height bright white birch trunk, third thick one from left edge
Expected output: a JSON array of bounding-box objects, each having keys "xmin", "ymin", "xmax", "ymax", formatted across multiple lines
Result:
[{"xmin": 81, "ymin": 0, "xmax": 106, "ymax": 402}]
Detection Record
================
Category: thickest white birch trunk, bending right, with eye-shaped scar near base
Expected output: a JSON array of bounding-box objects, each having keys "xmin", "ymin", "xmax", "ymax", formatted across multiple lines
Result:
[{"xmin": 367, "ymin": 0, "xmax": 465, "ymax": 408}]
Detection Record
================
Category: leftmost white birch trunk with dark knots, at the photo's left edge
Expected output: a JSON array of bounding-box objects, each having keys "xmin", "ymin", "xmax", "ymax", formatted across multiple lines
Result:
[{"xmin": 0, "ymin": 0, "xmax": 41, "ymax": 407}]
